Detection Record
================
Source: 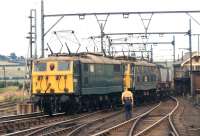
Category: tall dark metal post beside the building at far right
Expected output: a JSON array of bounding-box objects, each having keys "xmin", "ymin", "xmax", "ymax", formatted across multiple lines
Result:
[{"xmin": 188, "ymin": 19, "xmax": 194, "ymax": 98}]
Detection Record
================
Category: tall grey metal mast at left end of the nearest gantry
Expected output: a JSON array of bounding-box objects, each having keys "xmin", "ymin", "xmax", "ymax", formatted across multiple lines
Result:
[{"xmin": 41, "ymin": 0, "xmax": 44, "ymax": 58}]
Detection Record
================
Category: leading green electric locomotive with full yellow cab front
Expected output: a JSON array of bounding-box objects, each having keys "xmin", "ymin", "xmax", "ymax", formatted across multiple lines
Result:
[{"xmin": 32, "ymin": 53, "xmax": 123, "ymax": 114}]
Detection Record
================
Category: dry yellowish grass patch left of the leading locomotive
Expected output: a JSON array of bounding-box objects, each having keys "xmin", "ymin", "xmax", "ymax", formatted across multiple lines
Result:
[{"xmin": 0, "ymin": 86, "xmax": 29, "ymax": 101}]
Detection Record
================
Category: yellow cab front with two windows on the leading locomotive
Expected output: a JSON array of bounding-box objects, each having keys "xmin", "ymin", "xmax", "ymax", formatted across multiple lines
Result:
[{"xmin": 32, "ymin": 60, "xmax": 73, "ymax": 94}]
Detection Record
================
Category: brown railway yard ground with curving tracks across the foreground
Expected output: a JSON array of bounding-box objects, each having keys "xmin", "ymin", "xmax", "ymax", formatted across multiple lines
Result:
[{"xmin": 0, "ymin": 97, "xmax": 200, "ymax": 136}]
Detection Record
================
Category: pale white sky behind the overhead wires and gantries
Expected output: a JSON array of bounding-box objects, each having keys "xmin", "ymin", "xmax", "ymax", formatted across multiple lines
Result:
[{"xmin": 0, "ymin": 0, "xmax": 200, "ymax": 60}]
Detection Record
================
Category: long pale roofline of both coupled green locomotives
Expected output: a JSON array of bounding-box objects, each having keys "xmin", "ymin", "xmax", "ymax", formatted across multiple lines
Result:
[{"xmin": 34, "ymin": 53, "xmax": 156, "ymax": 66}]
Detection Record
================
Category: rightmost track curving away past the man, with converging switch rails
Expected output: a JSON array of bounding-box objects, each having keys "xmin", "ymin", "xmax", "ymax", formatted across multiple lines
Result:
[{"xmin": 92, "ymin": 98, "xmax": 179, "ymax": 136}]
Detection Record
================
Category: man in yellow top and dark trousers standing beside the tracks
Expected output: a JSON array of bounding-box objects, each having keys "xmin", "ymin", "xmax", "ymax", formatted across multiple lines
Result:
[{"xmin": 122, "ymin": 88, "xmax": 133, "ymax": 120}]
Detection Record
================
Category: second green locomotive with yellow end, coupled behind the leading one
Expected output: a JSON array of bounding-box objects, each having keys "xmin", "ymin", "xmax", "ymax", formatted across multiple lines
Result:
[{"xmin": 124, "ymin": 61, "xmax": 159, "ymax": 105}]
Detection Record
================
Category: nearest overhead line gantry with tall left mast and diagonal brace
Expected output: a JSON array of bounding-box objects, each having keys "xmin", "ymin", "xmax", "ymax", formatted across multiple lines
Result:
[{"xmin": 41, "ymin": 0, "xmax": 200, "ymax": 57}]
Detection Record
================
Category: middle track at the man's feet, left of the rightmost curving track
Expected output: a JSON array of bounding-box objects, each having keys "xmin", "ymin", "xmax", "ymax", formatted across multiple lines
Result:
[{"xmin": 27, "ymin": 102, "xmax": 159, "ymax": 136}]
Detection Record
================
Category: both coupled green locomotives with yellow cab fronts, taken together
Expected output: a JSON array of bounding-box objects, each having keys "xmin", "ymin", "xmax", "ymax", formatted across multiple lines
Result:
[{"xmin": 32, "ymin": 53, "xmax": 172, "ymax": 114}]
